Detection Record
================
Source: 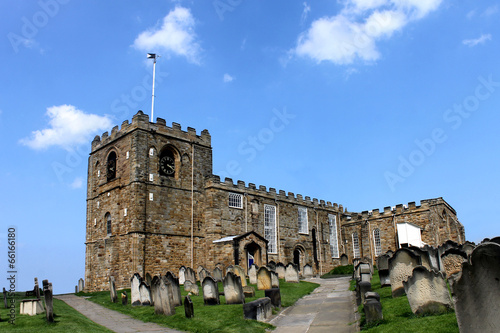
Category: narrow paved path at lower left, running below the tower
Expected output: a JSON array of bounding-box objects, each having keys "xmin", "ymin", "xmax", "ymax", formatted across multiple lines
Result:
[{"xmin": 54, "ymin": 294, "xmax": 180, "ymax": 333}]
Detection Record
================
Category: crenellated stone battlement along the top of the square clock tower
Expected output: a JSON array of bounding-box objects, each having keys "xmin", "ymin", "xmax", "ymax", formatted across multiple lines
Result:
[{"xmin": 92, "ymin": 110, "xmax": 212, "ymax": 151}]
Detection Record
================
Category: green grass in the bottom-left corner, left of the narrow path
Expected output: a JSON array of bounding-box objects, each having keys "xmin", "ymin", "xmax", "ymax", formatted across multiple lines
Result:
[{"xmin": 0, "ymin": 293, "xmax": 112, "ymax": 332}]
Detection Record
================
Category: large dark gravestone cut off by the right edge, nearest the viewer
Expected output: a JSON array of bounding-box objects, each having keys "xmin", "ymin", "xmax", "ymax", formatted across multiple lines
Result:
[{"xmin": 451, "ymin": 242, "xmax": 500, "ymax": 333}]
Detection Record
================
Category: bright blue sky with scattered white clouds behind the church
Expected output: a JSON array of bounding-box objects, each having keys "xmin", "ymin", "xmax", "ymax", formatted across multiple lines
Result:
[{"xmin": 0, "ymin": 0, "xmax": 500, "ymax": 293}]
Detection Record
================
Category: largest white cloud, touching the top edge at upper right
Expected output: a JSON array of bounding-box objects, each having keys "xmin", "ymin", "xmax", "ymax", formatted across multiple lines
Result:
[{"xmin": 292, "ymin": 0, "xmax": 442, "ymax": 65}]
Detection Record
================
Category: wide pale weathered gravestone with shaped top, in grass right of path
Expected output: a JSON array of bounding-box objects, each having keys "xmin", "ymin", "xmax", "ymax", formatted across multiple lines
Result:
[{"xmin": 403, "ymin": 266, "xmax": 452, "ymax": 315}]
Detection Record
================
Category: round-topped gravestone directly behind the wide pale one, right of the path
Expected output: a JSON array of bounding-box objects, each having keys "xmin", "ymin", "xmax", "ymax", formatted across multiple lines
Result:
[{"xmin": 389, "ymin": 248, "xmax": 422, "ymax": 297}]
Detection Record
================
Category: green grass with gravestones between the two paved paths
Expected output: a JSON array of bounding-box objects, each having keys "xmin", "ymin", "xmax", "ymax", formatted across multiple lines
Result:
[{"xmin": 78, "ymin": 280, "xmax": 319, "ymax": 332}]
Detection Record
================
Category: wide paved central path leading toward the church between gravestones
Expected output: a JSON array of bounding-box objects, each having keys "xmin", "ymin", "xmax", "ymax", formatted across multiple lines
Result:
[{"xmin": 269, "ymin": 277, "xmax": 359, "ymax": 333}]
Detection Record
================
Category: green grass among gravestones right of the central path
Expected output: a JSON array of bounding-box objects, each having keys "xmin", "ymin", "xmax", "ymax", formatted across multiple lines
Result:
[{"xmin": 359, "ymin": 271, "xmax": 458, "ymax": 333}]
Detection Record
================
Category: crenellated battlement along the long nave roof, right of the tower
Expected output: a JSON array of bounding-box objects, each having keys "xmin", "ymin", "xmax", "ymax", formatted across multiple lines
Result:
[{"xmin": 206, "ymin": 175, "xmax": 343, "ymax": 211}]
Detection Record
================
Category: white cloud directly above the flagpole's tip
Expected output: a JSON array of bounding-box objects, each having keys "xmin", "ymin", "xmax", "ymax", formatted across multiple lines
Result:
[{"xmin": 134, "ymin": 7, "xmax": 201, "ymax": 64}]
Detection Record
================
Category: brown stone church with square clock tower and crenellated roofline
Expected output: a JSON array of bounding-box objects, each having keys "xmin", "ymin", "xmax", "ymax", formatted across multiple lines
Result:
[{"xmin": 85, "ymin": 111, "xmax": 465, "ymax": 291}]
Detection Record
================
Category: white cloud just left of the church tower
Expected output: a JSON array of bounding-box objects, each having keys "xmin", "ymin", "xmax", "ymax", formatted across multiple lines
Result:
[{"xmin": 20, "ymin": 105, "xmax": 112, "ymax": 150}]
